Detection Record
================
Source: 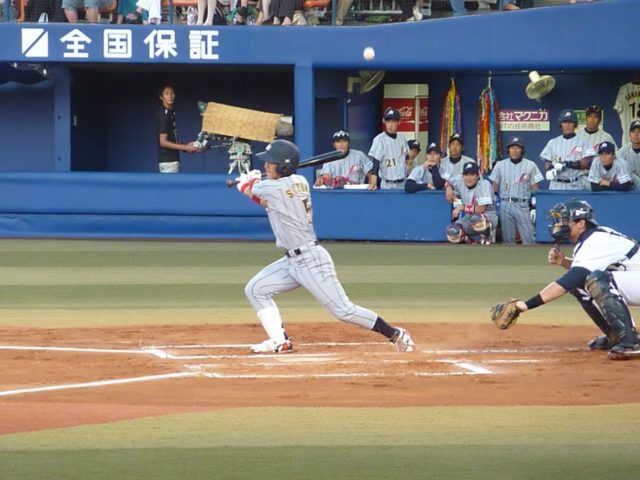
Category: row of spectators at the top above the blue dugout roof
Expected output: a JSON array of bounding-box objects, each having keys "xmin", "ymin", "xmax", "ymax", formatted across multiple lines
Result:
[{"xmin": 0, "ymin": 0, "xmax": 591, "ymax": 26}]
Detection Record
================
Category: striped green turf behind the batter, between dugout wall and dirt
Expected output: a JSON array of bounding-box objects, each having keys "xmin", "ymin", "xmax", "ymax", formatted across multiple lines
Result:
[{"xmin": 0, "ymin": 240, "xmax": 620, "ymax": 327}]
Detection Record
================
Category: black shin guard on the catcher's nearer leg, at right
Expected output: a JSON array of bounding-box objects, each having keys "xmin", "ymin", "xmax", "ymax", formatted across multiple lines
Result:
[{"xmin": 585, "ymin": 270, "xmax": 638, "ymax": 346}]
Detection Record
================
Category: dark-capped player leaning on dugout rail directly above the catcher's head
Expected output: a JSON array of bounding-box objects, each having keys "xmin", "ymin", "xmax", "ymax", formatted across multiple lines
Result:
[{"xmin": 589, "ymin": 142, "xmax": 633, "ymax": 192}]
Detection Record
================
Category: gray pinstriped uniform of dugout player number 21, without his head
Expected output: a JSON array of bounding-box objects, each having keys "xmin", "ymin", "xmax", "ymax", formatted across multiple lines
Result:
[{"xmin": 369, "ymin": 132, "xmax": 409, "ymax": 190}]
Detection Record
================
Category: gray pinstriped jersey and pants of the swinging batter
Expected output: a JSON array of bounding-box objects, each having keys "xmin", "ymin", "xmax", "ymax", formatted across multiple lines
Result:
[{"xmin": 245, "ymin": 174, "xmax": 378, "ymax": 329}]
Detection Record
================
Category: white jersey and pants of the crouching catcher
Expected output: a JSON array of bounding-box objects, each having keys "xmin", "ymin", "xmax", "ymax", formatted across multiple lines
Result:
[{"xmin": 571, "ymin": 227, "xmax": 640, "ymax": 305}]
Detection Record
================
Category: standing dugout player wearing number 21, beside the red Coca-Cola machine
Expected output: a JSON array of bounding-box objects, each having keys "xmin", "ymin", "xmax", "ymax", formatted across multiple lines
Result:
[{"xmin": 369, "ymin": 107, "xmax": 409, "ymax": 190}]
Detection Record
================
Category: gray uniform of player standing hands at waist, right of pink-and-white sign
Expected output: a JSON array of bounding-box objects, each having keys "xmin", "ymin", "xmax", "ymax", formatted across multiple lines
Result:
[{"xmin": 540, "ymin": 135, "xmax": 595, "ymax": 190}]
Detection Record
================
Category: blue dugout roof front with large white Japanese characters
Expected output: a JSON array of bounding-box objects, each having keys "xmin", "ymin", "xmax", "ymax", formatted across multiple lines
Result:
[{"xmin": 0, "ymin": 0, "xmax": 640, "ymax": 72}]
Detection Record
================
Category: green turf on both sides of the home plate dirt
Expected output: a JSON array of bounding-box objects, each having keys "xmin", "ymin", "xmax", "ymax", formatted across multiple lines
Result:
[{"xmin": 0, "ymin": 240, "xmax": 640, "ymax": 480}]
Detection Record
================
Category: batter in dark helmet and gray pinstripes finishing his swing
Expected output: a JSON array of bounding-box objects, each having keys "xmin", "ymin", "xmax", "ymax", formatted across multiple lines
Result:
[{"xmin": 237, "ymin": 140, "xmax": 414, "ymax": 353}]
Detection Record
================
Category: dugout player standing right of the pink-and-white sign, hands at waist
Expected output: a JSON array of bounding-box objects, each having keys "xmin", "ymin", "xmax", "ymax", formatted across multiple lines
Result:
[{"xmin": 540, "ymin": 110, "xmax": 595, "ymax": 190}]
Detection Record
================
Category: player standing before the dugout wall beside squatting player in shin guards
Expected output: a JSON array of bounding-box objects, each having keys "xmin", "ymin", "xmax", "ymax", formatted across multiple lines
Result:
[{"xmin": 489, "ymin": 137, "xmax": 544, "ymax": 245}]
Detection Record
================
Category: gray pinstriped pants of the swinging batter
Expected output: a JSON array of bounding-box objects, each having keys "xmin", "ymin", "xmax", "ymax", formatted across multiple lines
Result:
[{"xmin": 244, "ymin": 245, "xmax": 378, "ymax": 330}]
